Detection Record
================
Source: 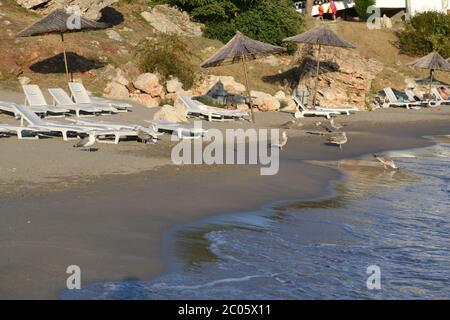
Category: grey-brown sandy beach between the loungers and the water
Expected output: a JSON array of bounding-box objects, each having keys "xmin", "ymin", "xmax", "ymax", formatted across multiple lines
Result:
[{"xmin": 0, "ymin": 87, "xmax": 450, "ymax": 299}]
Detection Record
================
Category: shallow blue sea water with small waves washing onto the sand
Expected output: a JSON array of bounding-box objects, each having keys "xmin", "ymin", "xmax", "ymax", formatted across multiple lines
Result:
[{"xmin": 61, "ymin": 140, "xmax": 450, "ymax": 299}]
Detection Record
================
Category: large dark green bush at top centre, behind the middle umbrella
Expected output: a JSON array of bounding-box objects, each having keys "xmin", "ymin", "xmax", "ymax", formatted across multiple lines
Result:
[{"xmin": 167, "ymin": 0, "xmax": 303, "ymax": 49}]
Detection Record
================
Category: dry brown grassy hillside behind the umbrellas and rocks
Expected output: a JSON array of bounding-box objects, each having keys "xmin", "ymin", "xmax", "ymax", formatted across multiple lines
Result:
[{"xmin": 0, "ymin": 0, "xmax": 450, "ymax": 94}]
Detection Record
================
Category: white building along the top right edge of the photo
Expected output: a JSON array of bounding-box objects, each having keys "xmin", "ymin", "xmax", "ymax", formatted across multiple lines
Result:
[{"xmin": 295, "ymin": 0, "xmax": 450, "ymax": 16}]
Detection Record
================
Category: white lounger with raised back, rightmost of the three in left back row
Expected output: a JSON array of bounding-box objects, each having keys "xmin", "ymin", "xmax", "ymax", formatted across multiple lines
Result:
[{"xmin": 69, "ymin": 82, "xmax": 133, "ymax": 112}]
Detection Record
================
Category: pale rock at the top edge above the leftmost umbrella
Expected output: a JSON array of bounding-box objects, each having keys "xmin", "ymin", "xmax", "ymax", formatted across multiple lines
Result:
[{"xmin": 16, "ymin": 0, "xmax": 118, "ymax": 20}]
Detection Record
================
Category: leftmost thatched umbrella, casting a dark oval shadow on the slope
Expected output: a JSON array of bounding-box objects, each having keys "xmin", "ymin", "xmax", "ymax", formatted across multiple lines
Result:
[{"xmin": 16, "ymin": 9, "xmax": 108, "ymax": 78}]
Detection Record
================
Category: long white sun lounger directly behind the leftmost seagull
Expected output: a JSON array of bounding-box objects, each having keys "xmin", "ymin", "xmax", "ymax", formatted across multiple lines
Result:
[{"xmin": 14, "ymin": 105, "xmax": 134, "ymax": 144}]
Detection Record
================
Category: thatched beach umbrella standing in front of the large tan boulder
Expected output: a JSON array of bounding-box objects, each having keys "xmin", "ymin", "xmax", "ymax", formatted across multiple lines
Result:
[{"xmin": 283, "ymin": 25, "xmax": 355, "ymax": 105}]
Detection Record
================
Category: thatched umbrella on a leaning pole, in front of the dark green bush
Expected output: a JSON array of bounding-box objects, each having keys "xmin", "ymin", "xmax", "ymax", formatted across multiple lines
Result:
[{"xmin": 200, "ymin": 31, "xmax": 285, "ymax": 122}]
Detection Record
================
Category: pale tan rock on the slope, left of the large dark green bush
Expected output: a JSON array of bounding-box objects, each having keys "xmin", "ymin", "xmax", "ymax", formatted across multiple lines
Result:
[{"xmin": 141, "ymin": 5, "xmax": 203, "ymax": 37}]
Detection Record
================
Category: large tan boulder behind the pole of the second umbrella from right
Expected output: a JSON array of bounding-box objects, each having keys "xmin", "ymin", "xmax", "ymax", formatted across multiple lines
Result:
[{"xmin": 297, "ymin": 48, "xmax": 383, "ymax": 109}]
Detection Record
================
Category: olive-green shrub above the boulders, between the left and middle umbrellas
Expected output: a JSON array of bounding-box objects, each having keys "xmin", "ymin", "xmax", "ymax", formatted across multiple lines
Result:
[{"xmin": 137, "ymin": 34, "xmax": 196, "ymax": 89}]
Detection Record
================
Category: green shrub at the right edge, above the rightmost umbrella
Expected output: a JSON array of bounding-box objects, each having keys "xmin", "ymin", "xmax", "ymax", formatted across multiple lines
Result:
[{"xmin": 397, "ymin": 11, "xmax": 450, "ymax": 58}]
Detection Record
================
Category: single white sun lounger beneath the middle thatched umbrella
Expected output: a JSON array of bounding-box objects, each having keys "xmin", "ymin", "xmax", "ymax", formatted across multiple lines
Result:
[{"xmin": 178, "ymin": 95, "xmax": 249, "ymax": 121}]
